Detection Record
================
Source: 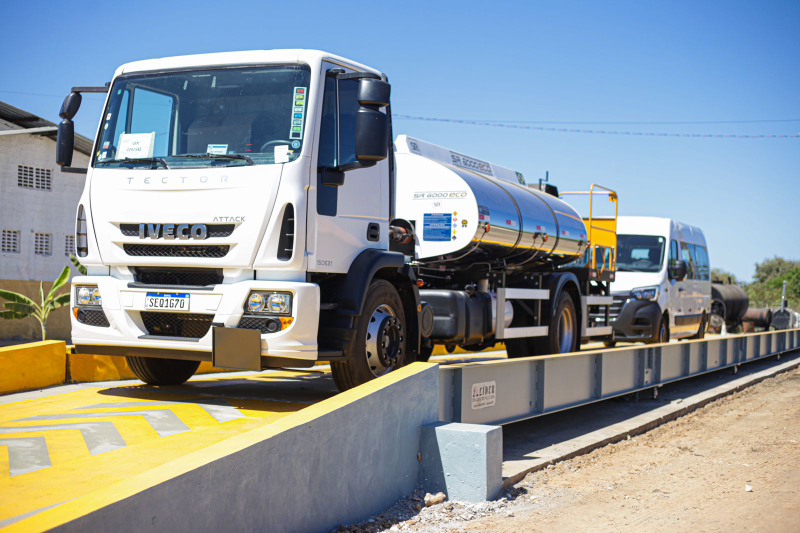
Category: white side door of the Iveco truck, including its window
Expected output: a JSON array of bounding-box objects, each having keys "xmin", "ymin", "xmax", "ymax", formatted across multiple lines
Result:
[{"xmin": 308, "ymin": 63, "xmax": 389, "ymax": 273}]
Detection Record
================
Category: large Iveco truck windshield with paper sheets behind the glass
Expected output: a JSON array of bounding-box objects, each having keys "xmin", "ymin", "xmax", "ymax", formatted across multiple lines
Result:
[{"xmin": 94, "ymin": 65, "xmax": 310, "ymax": 168}]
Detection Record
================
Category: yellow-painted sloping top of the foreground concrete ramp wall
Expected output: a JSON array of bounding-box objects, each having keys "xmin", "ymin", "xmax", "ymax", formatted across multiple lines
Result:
[{"xmin": 9, "ymin": 363, "xmax": 438, "ymax": 532}]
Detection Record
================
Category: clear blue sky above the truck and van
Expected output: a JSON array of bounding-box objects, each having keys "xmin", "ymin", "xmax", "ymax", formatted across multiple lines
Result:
[{"xmin": 0, "ymin": 0, "xmax": 800, "ymax": 279}]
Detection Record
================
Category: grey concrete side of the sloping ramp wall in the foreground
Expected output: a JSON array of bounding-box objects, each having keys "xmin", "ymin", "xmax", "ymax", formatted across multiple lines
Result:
[{"xmin": 56, "ymin": 363, "xmax": 439, "ymax": 533}]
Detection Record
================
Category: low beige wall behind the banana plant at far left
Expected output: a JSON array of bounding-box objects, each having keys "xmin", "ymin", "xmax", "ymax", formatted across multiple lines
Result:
[{"xmin": 0, "ymin": 278, "xmax": 75, "ymax": 341}]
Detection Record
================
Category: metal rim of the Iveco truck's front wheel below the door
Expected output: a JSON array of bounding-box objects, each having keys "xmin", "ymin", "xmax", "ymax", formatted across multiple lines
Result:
[{"xmin": 364, "ymin": 304, "xmax": 403, "ymax": 377}]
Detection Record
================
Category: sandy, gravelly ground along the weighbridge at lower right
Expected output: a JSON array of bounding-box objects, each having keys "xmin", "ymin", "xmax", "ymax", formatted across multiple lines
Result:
[{"xmin": 334, "ymin": 369, "xmax": 800, "ymax": 533}]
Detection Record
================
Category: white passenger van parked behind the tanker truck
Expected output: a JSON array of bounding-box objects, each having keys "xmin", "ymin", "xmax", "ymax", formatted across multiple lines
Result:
[{"xmin": 606, "ymin": 217, "xmax": 711, "ymax": 345}]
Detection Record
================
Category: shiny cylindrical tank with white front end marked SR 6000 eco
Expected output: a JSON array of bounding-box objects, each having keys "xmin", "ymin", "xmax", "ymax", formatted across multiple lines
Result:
[{"xmin": 395, "ymin": 135, "xmax": 586, "ymax": 268}]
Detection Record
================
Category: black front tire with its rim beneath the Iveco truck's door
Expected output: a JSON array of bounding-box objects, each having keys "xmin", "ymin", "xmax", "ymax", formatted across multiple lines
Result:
[{"xmin": 331, "ymin": 279, "xmax": 406, "ymax": 391}]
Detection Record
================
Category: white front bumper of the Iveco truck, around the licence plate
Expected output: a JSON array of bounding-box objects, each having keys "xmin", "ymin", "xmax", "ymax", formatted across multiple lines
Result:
[{"xmin": 70, "ymin": 276, "xmax": 320, "ymax": 361}]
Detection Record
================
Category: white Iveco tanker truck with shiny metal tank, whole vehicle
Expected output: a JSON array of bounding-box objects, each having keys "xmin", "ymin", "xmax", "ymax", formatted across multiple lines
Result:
[{"xmin": 56, "ymin": 50, "xmax": 616, "ymax": 390}]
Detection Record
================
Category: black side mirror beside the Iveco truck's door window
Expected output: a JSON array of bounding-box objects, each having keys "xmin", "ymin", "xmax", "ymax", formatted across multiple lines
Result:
[{"xmin": 355, "ymin": 78, "xmax": 391, "ymax": 168}]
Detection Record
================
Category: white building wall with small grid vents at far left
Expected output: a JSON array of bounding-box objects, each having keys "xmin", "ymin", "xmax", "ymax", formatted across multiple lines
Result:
[{"xmin": 0, "ymin": 120, "xmax": 89, "ymax": 281}]
